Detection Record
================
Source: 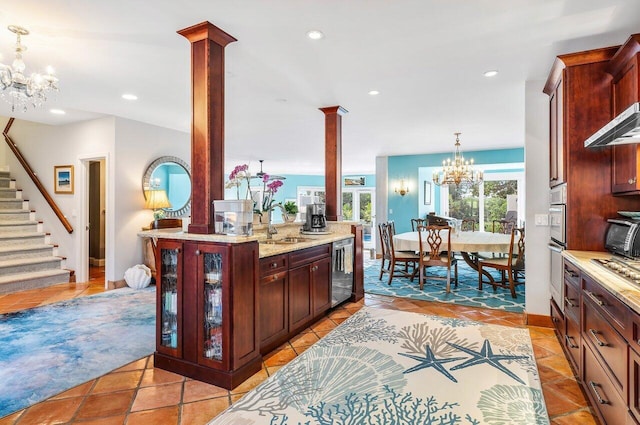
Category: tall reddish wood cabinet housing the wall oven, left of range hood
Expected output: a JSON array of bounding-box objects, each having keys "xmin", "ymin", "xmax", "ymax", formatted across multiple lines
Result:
[{"xmin": 544, "ymin": 47, "xmax": 625, "ymax": 251}]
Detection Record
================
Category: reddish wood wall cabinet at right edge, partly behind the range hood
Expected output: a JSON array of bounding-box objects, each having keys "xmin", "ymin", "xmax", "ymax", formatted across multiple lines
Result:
[{"xmin": 607, "ymin": 34, "xmax": 640, "ymax": 195}]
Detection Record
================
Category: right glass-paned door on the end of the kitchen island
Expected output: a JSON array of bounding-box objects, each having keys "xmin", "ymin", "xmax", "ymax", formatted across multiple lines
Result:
[{"xmin": 204, "ymin": 249, "xmax": 224, "ymax": 361}]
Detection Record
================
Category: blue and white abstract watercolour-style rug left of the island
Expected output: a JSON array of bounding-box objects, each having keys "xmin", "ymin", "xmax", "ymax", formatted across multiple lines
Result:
[{"xmin": 0, "ymin": 286, "xmax": 156, "ymax": 417}]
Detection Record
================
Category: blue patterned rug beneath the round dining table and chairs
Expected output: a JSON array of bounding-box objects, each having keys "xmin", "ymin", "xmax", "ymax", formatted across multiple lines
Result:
[{"xmin": 364, "ymin": 255, "xmax": 525, "ymax": 313}]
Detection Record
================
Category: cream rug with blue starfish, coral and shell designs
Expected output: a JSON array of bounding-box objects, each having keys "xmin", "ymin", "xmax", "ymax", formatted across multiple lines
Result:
[{"xmin": 209, "ymin": 307, "xmax": 549, "ymax": 425}]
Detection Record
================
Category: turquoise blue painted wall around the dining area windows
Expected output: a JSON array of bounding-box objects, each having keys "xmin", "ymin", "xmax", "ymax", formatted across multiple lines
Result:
[{"xmin": 387, "ymin": 148, "xmax": 524, "ymax": 233}]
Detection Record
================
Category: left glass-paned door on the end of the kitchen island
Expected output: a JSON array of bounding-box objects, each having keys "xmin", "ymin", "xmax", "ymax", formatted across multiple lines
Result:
[{"xmin": 157, "ymin": 242, "xmax": 182, "ymax": 351}]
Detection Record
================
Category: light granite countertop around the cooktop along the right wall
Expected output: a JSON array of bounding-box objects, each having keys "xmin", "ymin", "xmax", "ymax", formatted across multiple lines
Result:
[{"xmin": 562, "ymin": 250, "xmax": 640, "ymax": 314}]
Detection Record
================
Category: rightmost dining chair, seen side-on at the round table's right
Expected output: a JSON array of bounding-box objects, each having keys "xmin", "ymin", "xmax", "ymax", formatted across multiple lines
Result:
[{"xmin": 478, "ymin": 227, "xmax": 524, "ymax": 298}]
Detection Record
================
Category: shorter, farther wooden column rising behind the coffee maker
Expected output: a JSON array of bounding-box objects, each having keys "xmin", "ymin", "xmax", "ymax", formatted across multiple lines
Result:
[{"xmin": 320, "ymin": 106, "xmax": 349, "ymax": 221}]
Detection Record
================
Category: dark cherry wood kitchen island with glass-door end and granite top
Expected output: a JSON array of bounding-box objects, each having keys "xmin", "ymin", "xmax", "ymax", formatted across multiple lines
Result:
[{"xmin": 138, "ymin": 222, "xmax": 363, "ymax": 388}]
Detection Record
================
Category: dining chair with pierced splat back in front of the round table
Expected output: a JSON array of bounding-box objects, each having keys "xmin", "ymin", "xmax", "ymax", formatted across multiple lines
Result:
[{"xmin": 414, "ymin": 225, "xmax": 458, "ymax": 292}]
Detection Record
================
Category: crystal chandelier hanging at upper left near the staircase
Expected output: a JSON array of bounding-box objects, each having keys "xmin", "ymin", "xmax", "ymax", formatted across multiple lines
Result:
[{"xmin": 0, "ymin": 25, "xmax": 58, "ymax": 112}]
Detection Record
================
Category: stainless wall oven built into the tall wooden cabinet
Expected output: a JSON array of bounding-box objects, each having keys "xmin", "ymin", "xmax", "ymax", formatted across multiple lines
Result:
[{"xmin": 549, "ymin": 184, "xmax": 567, "ymax": 313}]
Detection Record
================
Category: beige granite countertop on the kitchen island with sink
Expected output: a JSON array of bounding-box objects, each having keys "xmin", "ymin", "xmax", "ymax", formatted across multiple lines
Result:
[{"xmin": 138, "ymin": 228, "xmax": 354, "ymax": 258}]
